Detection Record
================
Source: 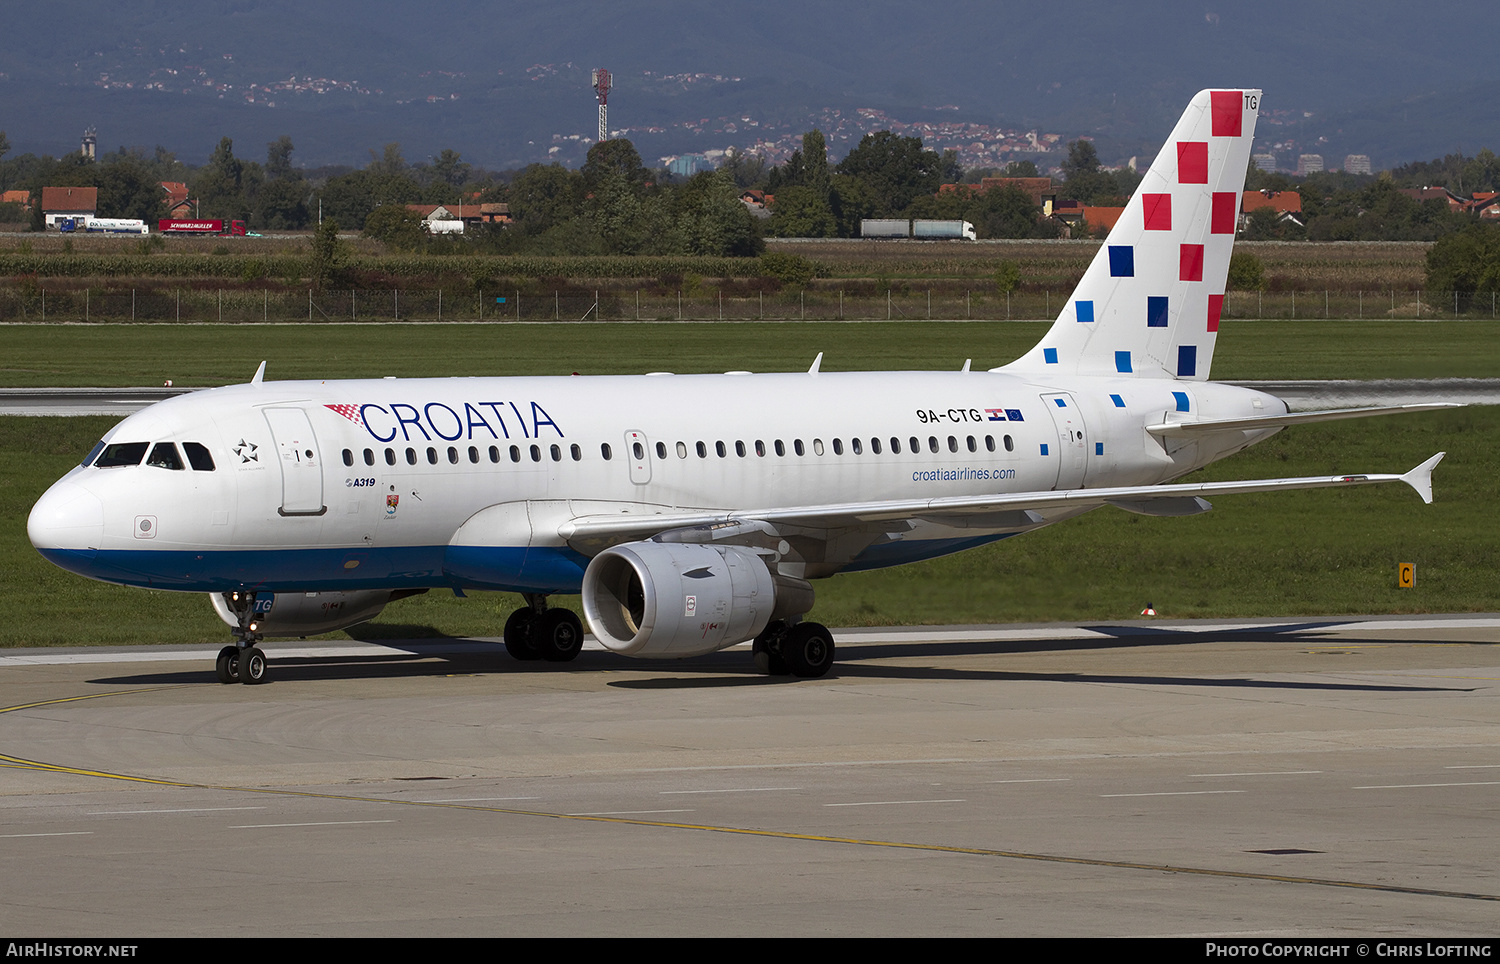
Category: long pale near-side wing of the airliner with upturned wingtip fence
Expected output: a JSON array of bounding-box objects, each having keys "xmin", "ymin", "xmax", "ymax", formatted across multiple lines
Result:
[{"xmin": 558, "ymin": 451, "xmax": 1448, "ymax": 552}]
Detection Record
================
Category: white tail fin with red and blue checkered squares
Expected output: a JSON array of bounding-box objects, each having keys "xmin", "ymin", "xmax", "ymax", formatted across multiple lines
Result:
[{"xmin": 1005, "ymin": 90, "xmax": 1260, "ymax": 381}]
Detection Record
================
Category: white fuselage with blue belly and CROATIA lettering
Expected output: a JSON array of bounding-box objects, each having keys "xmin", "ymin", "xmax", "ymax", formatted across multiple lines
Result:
[{"xmin": 29, "ymin": 372, "xmax": 1286, "ymax": 592}]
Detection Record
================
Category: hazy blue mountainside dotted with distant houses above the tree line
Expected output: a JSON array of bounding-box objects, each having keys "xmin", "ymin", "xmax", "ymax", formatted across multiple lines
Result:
[{"xmin": 0, "ymin": 0, "xmax": 1500, "ymax": 168}]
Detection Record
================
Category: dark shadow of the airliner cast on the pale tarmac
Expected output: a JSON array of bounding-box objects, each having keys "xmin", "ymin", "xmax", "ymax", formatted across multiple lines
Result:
[{"xmin": 90, "ymin": 621, "xmax": 1475, "ymax": 693}]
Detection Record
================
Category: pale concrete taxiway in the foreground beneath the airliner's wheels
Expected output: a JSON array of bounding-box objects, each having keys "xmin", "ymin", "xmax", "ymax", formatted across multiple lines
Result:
[{"xmin": 0, "ymin": 616, "xmax": 1500, "ymax": 937}]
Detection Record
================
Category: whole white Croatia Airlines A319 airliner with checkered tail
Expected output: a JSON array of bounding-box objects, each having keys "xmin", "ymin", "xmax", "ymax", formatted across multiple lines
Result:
[{"xmin": 27, "ymin": 90, "xmax": 1443, "ymax": 684}]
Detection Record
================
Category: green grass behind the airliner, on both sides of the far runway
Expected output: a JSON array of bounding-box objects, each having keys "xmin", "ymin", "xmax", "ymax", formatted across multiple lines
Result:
[{"xmin": 0, "ymin": 322, "xmax": 1500, "ymax": 646}]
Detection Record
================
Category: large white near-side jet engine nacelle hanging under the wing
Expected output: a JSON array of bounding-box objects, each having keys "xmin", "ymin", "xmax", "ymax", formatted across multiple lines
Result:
[{"xmin": 584, "ymin": 541, "xmax": 813, "ymax": 660}]
